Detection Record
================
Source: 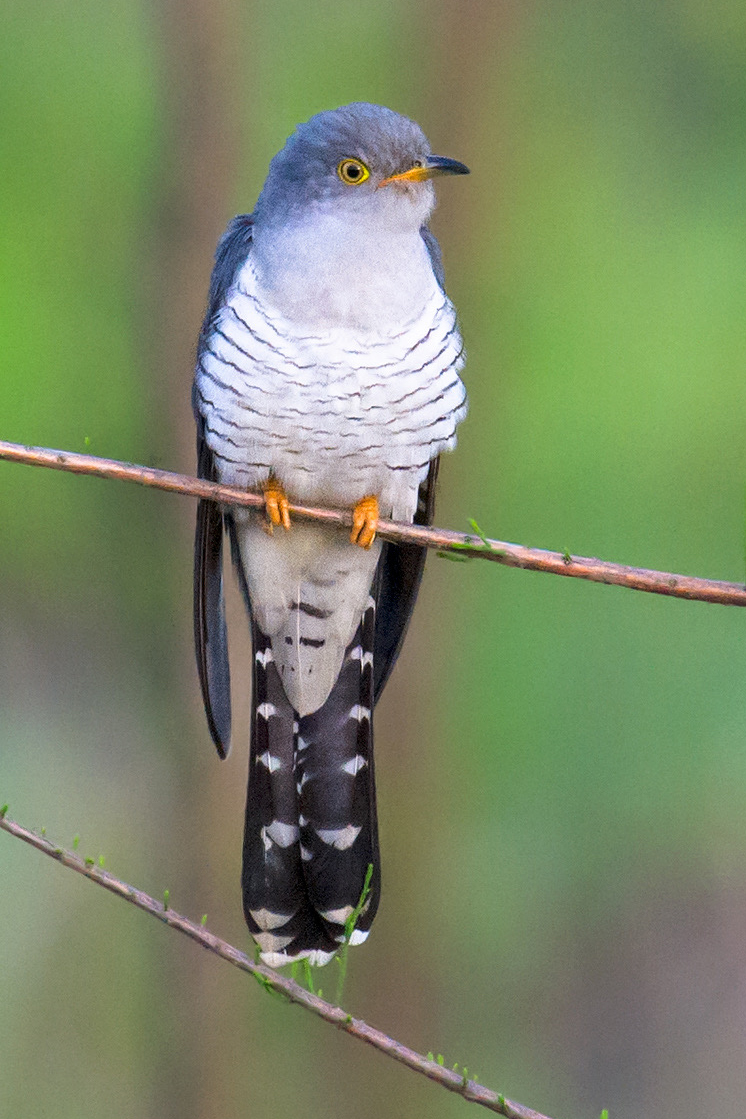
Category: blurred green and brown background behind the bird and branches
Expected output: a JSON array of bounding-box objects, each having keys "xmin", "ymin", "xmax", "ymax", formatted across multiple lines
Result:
[{"xmin": 0, "ymin": 0, "xmax": 746, "ymax": 1119}]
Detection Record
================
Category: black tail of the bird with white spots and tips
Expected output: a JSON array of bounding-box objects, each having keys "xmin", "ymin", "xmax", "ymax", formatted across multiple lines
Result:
[{"xmin": 242, "ymin": 598, "xmax": 380, "ymax": 966}]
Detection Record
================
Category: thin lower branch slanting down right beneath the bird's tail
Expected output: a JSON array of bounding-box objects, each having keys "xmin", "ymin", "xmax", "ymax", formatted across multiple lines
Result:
[{"xmin": 0, "ymin": 806, "xmax": 548, "ymax": 1119}]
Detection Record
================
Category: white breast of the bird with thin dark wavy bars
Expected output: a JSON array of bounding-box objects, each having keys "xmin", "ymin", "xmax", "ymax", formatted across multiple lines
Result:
[{"xmin": 197, "ymin": 251, "xmax": 465, "ymax": 520}]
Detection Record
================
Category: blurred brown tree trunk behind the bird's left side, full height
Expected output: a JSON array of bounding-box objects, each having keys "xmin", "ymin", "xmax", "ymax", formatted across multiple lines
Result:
[{"xmin": 145, "ymin": 0, "xmax": 247, "ymax": 1119}]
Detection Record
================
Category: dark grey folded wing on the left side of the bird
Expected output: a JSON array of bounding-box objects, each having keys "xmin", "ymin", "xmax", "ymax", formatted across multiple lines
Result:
[{"xmin": 192, "ymin": 214, "xmax": 253, "ymax": 758}]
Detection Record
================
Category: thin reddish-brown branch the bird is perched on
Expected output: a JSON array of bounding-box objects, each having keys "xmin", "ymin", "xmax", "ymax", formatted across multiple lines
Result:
[{"xmin": 0, "ymin": 441, "xmax": 746, "ymax": 606}]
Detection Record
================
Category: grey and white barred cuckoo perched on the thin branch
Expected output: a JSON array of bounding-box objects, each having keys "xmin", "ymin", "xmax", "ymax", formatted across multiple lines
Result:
[{"xmin": 192, "ymin": 102, "xmax": 469, "ymax": 967}]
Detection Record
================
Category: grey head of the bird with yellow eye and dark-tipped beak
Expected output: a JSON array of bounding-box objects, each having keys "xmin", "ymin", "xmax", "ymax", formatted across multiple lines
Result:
[{"xmin": 254, "ymin": 102, "xmax": 468, "ymax": 236}]
